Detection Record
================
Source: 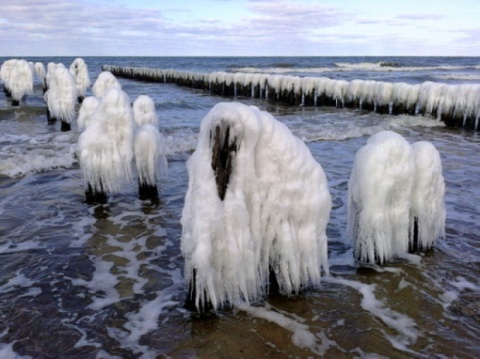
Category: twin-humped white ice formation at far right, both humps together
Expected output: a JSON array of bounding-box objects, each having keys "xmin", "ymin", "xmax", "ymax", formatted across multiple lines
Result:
[{"xmin": 348, "ymin": 131, "xmax": 446, "ymax": 264}]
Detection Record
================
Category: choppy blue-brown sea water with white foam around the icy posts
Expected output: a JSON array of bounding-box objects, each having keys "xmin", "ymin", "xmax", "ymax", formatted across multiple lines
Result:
[{"xmin": 0, "ymin": 57, "xmax": 480, "ymax": 358}]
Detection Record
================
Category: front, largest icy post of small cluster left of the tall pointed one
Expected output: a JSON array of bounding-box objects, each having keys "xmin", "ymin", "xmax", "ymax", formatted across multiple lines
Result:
[{"xmin": 45, "ymin": 64, "xmax": 77, "ymax": 131}]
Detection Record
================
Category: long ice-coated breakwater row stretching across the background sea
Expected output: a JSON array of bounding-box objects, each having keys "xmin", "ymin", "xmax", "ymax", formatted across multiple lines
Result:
[{"xmin": 102, "ymin": 65, "xmax": 480, "ymax": 130}]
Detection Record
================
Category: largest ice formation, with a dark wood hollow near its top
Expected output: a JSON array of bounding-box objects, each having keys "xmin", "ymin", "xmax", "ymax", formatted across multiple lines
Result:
[{"xmin": 181, "ymin": 103, "xmax": 331, "ymax": 310}]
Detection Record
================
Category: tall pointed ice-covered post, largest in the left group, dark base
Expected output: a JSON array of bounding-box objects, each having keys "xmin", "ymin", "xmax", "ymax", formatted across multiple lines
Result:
[{"xmin": 77, "ymin": 88, "xmax": 134, "ymax": 203}]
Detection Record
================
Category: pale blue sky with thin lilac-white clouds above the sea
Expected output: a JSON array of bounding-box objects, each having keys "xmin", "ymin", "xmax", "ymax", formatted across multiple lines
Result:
[{"xmin": 0, "ymin": 0, "xmax": 480, "ymax": 57}]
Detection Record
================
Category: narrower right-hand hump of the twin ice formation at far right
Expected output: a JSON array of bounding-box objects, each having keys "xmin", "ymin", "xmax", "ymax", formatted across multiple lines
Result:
[{"xmin": 409, "ymin": 141, "xmax": 446, "ymax": 252}]
